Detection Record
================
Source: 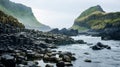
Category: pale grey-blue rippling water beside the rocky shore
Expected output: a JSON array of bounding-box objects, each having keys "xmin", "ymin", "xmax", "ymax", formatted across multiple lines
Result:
[{"xmin": 39, "ymin": 35, "xmax": 120, "ymax": 67}]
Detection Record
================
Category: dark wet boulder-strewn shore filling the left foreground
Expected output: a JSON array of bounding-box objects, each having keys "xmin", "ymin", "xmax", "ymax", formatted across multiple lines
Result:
[{"xmin": 0, "ymin": 29, "xmax": 85, "ymax": 67}]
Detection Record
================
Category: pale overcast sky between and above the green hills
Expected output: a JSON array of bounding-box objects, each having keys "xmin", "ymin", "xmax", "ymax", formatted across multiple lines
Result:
[{"xmin": 11, "ymin": 0, "xmax": 120, "ymax": 28}]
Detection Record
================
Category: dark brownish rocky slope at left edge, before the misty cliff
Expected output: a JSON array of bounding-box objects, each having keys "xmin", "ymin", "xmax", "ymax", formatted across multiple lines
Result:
[{"xmin": 0, "ymin": 11, "xmax": 25, "ymax": 34}]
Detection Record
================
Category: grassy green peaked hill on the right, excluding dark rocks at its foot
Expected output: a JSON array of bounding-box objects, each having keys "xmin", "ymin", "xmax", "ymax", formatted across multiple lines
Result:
[{"xmin": 72, "ymin": 6, "xmax": 120, "ymax": 31}]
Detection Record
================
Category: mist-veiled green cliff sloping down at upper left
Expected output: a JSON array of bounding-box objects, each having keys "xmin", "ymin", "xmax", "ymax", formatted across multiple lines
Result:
[{"xmin": 0, "ymin": 0, "xmax": 50, "ymax": 30}]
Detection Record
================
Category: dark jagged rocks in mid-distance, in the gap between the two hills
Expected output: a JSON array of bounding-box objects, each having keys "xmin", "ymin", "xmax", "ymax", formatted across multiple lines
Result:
[{"xmin": 49, "ymin": 28, "xmax": 78, "ymax": 36}]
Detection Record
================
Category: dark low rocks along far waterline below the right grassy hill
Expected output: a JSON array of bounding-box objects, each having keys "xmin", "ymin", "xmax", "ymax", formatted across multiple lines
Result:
[{"xmin": 79, "ymin": 28, "xmax": 120, "ymax": 40}]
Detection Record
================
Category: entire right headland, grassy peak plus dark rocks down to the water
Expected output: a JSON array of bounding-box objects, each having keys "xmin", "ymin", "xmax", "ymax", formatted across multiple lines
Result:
[{"xmin": 71, "ymin": 6, "xmax": 120, "ymax": 40}]
